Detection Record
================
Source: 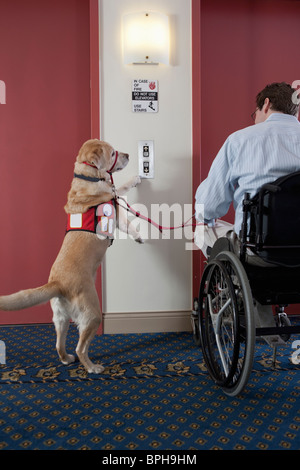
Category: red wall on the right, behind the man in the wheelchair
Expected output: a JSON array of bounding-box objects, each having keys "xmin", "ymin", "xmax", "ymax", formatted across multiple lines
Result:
[{"xmin": 192, "ymin": 0, "xmax": 300, "ymax": 304}]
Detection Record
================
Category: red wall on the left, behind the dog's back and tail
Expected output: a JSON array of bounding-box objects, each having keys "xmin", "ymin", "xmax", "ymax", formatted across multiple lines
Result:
[{"xmin": 0, "ymin": 0, "xmax": 91, "ymax": 323}]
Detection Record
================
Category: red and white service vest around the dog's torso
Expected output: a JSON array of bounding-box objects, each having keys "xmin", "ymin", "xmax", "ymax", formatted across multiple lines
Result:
[{"xmin": 66, "ymin": 200, "xmax": 116, "ymax": 238}]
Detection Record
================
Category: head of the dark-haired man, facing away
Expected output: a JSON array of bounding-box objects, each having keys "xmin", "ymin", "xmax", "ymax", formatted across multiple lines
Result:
[{"xmin": 255, "ymin": 82, "xmax": 299, "ymax": 124}]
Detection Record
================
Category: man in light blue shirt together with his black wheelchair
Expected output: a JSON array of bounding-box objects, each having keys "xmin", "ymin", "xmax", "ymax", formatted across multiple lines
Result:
[{"xmin": 194, "ymin": 82, "xmax": 300, "ymax": 395}]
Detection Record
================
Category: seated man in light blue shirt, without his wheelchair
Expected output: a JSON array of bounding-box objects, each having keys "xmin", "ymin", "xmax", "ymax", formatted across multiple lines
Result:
[{"xmin": 195, "ymin": 83, "xmax": 300, "ymax": 255}]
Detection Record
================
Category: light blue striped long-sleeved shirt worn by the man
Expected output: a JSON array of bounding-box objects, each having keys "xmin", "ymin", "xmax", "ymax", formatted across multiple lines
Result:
[{"xmin": 195, "ymin": 113, "xmax": 300, "ymax": 234}]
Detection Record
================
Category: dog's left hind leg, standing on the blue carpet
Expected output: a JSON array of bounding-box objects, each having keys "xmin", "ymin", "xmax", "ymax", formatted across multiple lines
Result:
[{"xmin": 51, "ymin": 298, "xmax": 75, "ymax": 365}]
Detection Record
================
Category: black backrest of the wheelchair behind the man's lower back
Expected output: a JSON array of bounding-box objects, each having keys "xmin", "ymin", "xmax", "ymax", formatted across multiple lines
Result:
[{"xmin": 248, "ymin": 171, "xmax": 300, "ymax": 266}]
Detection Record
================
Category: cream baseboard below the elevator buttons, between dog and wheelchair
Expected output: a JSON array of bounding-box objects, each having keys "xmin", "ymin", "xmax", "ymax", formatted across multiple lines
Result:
[{"xmin": 103, "ymin": 311, "xmax": 192, "ymax": 334}]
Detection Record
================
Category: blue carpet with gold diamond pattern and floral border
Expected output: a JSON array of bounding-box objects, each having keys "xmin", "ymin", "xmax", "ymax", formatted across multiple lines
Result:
[{"xmin": 0, "ymin": 325, "xmax": 300, "ymax": 451}]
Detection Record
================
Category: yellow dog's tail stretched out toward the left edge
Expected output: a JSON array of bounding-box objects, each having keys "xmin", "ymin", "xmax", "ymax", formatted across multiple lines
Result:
[{"xmin": 0, "ymin": 282, "xmax": 61, "ymax": 310}]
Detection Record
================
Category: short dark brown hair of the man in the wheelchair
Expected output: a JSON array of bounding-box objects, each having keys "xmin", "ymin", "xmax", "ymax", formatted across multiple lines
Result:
[{"xmin": 256, "ymin": 82, "xmax": 299, "ymax": 116}]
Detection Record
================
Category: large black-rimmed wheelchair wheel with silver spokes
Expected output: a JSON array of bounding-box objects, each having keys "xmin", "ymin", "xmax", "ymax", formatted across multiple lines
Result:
[{"xmin": 199, "ymin": 251, "xmax": 255, "ymax": 396}]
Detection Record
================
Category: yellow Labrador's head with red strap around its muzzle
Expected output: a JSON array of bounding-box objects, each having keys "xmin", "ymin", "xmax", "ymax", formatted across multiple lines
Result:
[{"xmin": 76, "ymin": 139, "xmax": 129, "ymax": 172}]
